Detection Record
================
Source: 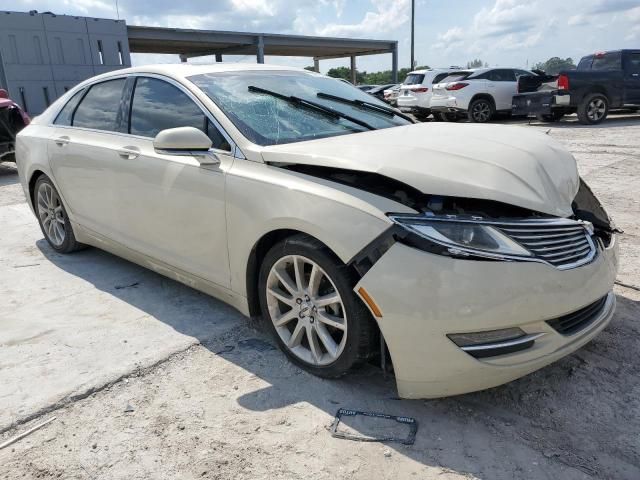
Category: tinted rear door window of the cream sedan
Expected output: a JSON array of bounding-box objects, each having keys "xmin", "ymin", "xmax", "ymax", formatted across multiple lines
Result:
[{"xmin": 73, "ymin": 78, "xmax": 125, "ymax": 132}]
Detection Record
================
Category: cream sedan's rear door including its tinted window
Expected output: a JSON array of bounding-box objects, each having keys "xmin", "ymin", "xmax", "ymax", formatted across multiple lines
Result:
[{"xmin": 48, "ymin": 77, "xmax": 126, "ymax": 236}]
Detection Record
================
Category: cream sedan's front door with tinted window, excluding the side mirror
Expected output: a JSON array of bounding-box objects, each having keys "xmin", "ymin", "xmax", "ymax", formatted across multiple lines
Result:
[{"xmin": 110, "ymin": 75, "xmax": 234, "ymax": 287}]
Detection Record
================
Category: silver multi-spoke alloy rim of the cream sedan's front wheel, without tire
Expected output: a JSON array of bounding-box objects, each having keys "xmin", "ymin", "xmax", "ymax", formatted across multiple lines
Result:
[{"xmin": 266, "ymin": 255, "xmax": 347, "ymax": 366}]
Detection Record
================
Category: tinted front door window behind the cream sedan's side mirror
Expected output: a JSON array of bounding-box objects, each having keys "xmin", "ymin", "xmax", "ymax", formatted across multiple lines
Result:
[{"xmin": 129, "ymin": 77, "xmax": 231, "ymax": 151}]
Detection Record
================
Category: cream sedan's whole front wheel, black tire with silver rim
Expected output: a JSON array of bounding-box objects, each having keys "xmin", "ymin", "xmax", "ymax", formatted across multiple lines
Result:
[{"xmin": 258, "ymin": 234, "xmax": 374, "ymax": 378}]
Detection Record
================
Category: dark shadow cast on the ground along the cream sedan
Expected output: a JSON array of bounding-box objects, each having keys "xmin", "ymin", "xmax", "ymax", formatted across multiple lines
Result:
[{"xmin": 37, "ymin": 240, "xmax": 640, "ymax": 479}]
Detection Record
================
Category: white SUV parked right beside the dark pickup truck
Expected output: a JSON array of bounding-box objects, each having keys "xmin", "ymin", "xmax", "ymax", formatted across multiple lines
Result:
[{"xmin": 431, "ymin": 68, "xmax": 535, "ymax": 123}]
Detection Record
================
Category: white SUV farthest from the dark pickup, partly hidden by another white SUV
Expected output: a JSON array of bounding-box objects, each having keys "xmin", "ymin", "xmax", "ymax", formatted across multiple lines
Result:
[{"xmin": 397, "ymin": 68, "xmax": 460, "ymax": 120}]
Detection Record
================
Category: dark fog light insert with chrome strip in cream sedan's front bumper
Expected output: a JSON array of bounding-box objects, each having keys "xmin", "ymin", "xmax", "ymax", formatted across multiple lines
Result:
[{"xmin": 447, "ymin": 328, "xmax": 544, "ymax": 358}]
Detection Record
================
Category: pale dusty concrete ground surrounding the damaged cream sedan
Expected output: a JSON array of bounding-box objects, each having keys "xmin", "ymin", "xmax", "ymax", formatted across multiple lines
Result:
[{"xmin": 0, "ymin": 116, "xmax": 640, "ymax": 479}]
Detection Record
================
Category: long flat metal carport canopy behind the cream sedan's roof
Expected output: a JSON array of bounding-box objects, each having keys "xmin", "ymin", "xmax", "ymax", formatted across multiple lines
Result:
[{"xmin": 127, "ymin": 25, "xmax": 398, "ymax": 81}]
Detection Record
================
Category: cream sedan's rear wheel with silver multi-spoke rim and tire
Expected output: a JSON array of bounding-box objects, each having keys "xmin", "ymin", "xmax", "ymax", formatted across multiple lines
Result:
[{"xmin": 33, "ymin": 175, "xmax": 84, "ymax": 253}]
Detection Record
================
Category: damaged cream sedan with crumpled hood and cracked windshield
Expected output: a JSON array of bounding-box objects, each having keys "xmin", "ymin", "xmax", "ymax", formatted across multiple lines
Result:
[{"xmin": 16, "ymin": 64, "xmax": 618, "ymax": 398}]
